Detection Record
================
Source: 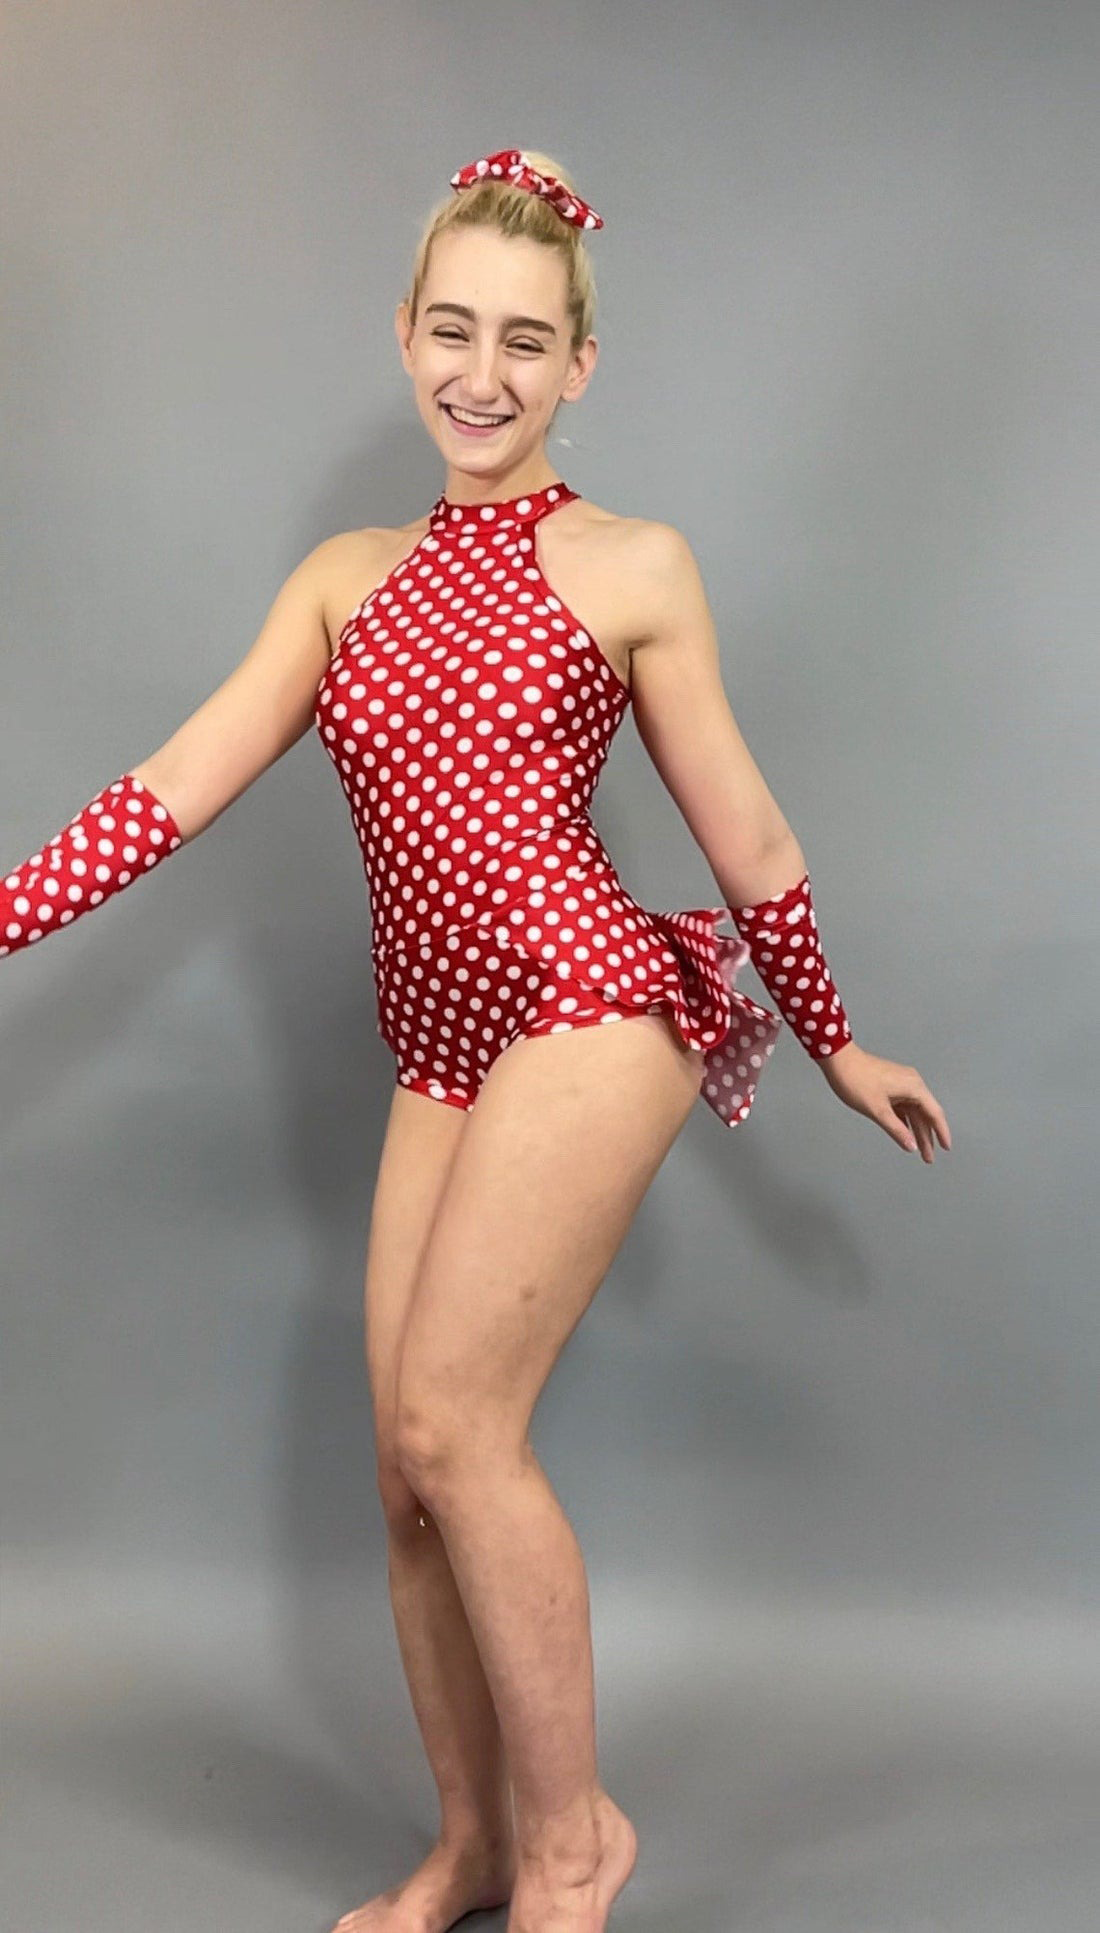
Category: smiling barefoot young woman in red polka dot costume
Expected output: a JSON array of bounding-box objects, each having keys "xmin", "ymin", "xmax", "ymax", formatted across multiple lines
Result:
[{"xmin": 0, "ymin": 149, "xmax": 951, "ymax": 1933}]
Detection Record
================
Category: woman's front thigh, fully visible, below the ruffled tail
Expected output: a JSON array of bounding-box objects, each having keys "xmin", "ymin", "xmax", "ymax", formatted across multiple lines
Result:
[{"xmin": 398, "ymin": 1013, "xmax": 702, "ymax": 1461}]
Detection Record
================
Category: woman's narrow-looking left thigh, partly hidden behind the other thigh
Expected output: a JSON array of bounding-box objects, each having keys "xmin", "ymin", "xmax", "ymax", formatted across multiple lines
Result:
[{"xmin": 363, "ymin": 1086, "xmax": 470, "ymax": 1473}]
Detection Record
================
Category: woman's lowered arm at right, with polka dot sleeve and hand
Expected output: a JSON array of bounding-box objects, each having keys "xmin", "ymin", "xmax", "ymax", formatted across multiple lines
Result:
[{"xmin": 630, "ymin": 524, "xmax": 951, "ymax": 1164}]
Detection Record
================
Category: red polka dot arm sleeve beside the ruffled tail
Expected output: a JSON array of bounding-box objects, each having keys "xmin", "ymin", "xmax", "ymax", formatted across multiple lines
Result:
[{"xmin": 729, "ymin": 872, "xmax": 853, "ymax": 1061}]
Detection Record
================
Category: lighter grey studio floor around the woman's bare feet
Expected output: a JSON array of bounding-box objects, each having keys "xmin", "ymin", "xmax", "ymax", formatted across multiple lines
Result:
[{"xmin": 0, "ymin": 1568, "xmax": 1100, "ymax": 1933}]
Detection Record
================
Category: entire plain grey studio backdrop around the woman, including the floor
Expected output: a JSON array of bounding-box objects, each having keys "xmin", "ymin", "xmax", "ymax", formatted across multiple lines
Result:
[{"xmin": 0, "ymin": 0, "xmax": 1100, "ymax": 1933}]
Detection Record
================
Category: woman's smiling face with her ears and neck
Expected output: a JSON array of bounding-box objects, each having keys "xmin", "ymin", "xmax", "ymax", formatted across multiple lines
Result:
[{"xmin": 394, "ymin": 228, "xmax": 597, "ymax": 503}]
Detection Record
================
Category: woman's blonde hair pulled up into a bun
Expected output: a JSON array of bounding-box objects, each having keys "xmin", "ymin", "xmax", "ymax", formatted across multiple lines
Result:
[{"xmin": 404, "ymin": 147, "xmax": 595, "ymax": 350}]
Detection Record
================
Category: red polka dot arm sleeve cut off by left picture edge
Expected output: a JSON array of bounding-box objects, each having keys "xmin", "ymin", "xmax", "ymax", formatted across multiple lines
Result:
[{"xmin": 0, "ymin": 771, "xmax": 184, "ymax": 959}]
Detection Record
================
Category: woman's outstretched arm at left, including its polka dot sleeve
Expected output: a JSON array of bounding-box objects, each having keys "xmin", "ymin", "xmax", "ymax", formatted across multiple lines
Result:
[{"xmin": 0, "ymin": 537, "xmax": 340, "ymax": 959}]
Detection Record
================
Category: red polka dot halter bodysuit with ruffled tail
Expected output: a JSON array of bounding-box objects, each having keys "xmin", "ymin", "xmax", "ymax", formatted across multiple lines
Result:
[{"xmin": 315, "ymin": 481, "xmax": 781, "ymax": 1127}]
